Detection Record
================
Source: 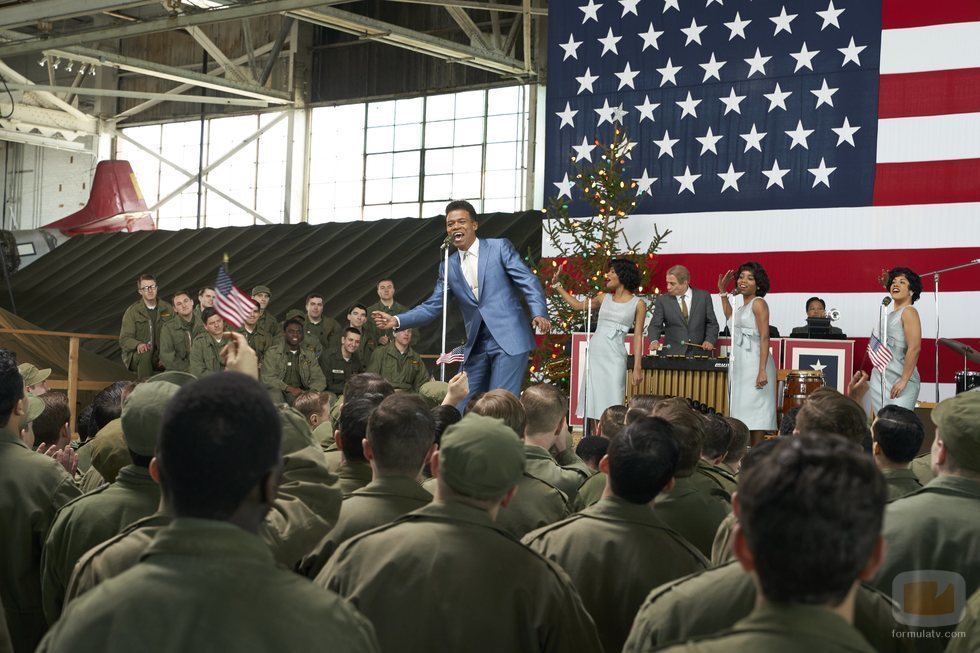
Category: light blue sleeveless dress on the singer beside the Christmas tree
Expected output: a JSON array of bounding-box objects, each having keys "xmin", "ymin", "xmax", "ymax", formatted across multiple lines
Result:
[{"xmin": 577, "ymin": 293, "xmax": 643, "ymax": 419}]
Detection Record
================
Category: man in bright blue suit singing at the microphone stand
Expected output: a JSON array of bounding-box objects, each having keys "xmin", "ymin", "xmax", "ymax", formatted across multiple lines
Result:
[{"xmin": 372, "ymin": 200, "xmax": 551, "ymax": 404}]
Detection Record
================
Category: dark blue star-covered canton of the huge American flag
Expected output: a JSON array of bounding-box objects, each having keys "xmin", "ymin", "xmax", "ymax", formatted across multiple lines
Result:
[{"xmin": 545, "ymin": 0, "xmax": 881, "ymax": 215}]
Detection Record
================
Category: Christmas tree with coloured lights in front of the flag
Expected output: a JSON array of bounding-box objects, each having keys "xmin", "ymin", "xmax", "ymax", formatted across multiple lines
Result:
[{"xmin": 530, "ymin": 124, "xmax": 670, "ymax": 393}]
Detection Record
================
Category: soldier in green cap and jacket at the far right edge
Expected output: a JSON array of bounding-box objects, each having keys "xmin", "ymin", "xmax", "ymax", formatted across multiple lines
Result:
[{"xmin": 874, "ymin": 392, "xmax": 980, "ymax": 650}]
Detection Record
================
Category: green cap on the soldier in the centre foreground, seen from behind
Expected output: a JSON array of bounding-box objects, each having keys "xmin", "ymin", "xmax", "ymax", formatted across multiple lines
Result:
[{"xmin": 439, "ymin": 413, "xmax": 525, "ymax": 500}]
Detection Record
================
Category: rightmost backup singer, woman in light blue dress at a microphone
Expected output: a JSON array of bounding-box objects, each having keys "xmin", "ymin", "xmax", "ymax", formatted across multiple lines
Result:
[{"xmin": 870, "ymin": 268, "xmax": 922, "ymax": 413}]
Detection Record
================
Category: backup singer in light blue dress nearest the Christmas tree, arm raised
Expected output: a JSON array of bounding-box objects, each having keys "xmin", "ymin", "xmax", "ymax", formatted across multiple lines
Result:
[{"xmin": 552, "ymin": 259, "xmax": 646, "ymax": 420}]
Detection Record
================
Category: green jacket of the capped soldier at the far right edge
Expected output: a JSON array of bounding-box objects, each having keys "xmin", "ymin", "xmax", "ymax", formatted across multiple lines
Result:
[{"xmin": 874, "ymin": 474, "xmax": 980, "ymax": 650}]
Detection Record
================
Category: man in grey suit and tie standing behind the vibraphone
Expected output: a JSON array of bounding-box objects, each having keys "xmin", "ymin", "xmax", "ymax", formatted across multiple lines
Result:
[{"xmin": 647, "ymin": 265, "xmax": 718, "ymax": 356}]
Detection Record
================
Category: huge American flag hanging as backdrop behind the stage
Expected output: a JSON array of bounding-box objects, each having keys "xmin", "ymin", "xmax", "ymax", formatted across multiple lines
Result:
[{"xmin": 544, "ymin": 0, "xmax": 980, "ymax": 400}]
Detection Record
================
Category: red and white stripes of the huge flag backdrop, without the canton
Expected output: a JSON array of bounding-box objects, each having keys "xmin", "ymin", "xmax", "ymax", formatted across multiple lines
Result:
[{"xmin": 543, "ymin": 0, "xmax": 980, "ymax": 401}]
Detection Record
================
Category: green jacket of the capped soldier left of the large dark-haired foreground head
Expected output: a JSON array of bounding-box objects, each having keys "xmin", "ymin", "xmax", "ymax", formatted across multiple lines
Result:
[{"xmin": 41, "ymin": 465, "xmax": 160, "ymax": 624}]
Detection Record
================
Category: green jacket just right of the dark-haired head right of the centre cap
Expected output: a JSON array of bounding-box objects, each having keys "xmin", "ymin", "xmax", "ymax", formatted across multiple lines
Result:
[{"xmin": 656, "ymin": 474, "xmax": 732, "ymax": 558}]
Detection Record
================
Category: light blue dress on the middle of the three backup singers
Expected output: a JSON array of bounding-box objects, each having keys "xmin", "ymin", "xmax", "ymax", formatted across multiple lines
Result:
[{"xmin": 728, "ymin": 297, "xmax": 776, "ymax": 431}]
